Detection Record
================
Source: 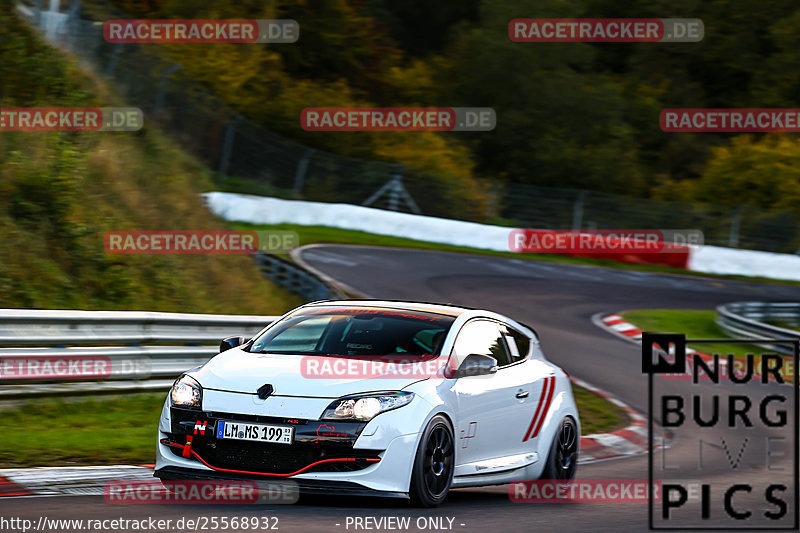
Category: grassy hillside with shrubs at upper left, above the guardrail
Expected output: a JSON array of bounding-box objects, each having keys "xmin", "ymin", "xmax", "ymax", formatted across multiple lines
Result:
[{"xmin": 0, "ymin": 0, "xmax": 297, "ymax": 314}]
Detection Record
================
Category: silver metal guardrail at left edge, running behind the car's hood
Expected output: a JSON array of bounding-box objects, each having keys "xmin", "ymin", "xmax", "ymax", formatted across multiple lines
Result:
[{"xmin": 0, "ymin": 309, "xmax": 277, "ymax": 399}]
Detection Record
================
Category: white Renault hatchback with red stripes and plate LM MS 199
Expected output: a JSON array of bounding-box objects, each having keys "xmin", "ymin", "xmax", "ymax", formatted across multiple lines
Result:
[{"xmin": 155, "ymin": 300, "xmax": 580, "ymax": 506}]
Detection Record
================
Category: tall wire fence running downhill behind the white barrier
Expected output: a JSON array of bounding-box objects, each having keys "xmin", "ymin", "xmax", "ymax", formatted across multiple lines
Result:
[{"xmin": 10, "ymin": 0, "xmax": 800, "ymax": 253}]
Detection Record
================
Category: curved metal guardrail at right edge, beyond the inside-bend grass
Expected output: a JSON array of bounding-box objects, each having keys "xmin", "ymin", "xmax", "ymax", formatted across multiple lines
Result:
[{"xmin": 716, "ymin": 302, "xmax": 800, "ymax": 354}]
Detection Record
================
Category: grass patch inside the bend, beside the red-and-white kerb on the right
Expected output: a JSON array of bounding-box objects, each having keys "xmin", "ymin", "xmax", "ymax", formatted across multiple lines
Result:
[{"xmin": 621, "ymin": 309, "xmax": 765, "ymax": 358}]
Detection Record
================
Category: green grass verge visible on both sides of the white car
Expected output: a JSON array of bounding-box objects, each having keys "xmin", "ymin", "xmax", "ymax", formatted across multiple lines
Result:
[{"xmin": 0, "ymin": 387, "xmax": 627, "ymax": 468}]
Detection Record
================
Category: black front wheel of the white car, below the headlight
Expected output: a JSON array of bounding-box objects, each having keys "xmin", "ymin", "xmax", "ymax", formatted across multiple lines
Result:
[{"xmin": 409, "ymin": 415, "xmax": 455, "ymax": 507}]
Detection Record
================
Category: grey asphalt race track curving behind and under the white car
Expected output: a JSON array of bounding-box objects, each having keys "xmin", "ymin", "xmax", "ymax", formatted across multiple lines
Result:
[{"xmin": 6, "ymin": 246, "xmax": 800, "ymax": 533}]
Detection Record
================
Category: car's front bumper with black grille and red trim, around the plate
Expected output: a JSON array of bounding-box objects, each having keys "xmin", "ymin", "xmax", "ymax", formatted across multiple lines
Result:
[{"xmin": 155, "ymin": 404, "xmax": 420, "ymax": 498}]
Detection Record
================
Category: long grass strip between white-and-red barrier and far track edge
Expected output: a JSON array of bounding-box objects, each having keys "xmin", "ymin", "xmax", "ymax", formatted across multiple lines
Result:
[{"xmin": 229, "ymin": 222, "xmax": 800, "ymax": 285}]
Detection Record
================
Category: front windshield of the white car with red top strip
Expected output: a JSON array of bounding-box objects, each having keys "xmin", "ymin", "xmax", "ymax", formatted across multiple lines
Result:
[{"xmin": 250, "ymin": 308, "xmax": 455, "ymax": 356}]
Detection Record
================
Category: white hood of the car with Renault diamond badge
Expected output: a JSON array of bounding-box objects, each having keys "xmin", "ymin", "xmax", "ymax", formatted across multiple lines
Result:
[{"xmin": 190, "ymin": 348, "xmax": 443, "ymax": 398}]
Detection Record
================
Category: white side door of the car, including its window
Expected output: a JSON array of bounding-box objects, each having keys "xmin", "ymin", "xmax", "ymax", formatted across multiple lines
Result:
[{"xmin": 451, "ymin": 319, "xmax": 541, "ymax": 473}]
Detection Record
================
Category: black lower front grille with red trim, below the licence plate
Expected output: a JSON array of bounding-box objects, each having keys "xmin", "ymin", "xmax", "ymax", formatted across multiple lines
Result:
[{"xmin": 170, "ymin": 440, "xmax": 379, "ymax": 474}]
